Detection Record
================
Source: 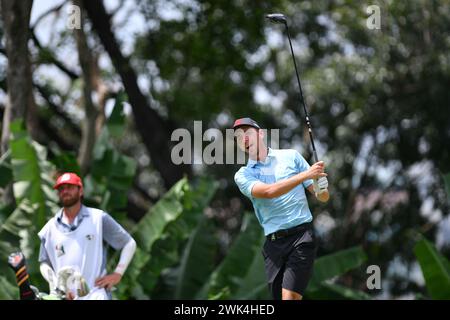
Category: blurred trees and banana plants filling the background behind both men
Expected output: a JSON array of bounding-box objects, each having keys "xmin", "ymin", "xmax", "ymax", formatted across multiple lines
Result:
[{"xmin": 0, "ymin": 0, "xmax": 450, "ymax": 299}]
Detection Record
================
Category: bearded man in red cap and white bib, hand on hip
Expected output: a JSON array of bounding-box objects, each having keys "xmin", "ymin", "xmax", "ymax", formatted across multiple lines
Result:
[{"xmin": 39, "ymin": 172, "xmax": 136, "ymax": 300}]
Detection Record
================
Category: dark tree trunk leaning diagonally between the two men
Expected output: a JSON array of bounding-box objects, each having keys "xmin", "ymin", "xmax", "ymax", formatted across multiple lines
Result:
[{"xmin": 82, "ymin": 0, "xmax": 191, "ymax": 188}]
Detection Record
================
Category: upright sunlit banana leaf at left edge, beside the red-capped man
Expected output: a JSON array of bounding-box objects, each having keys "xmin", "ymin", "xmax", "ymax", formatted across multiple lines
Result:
[{"xmin": 0, "ymin": 120, "xmax": 57, "ymax": 290}]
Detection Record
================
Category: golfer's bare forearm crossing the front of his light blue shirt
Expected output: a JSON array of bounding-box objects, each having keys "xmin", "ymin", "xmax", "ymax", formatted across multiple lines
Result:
[{"xmin": 252, "ymin": 171, "xmax": 310, "ymax": 199}]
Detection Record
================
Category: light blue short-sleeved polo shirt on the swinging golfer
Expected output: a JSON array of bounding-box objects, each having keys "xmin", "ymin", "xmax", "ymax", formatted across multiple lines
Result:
[{"xmin": 234, "ymin": 148, "xmax": 313, "ymax": 235}]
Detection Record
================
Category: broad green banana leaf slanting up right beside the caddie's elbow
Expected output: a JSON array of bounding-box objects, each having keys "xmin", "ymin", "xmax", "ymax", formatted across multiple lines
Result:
[{"xmin": 112, "ymin": 178, "xmax": 218, "ymax": 299}]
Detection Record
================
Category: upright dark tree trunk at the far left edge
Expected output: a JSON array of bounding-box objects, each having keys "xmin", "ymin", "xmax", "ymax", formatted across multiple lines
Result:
[{"xmin": 1, "ymin": 0, "xmax": 39, "ymax": 153}]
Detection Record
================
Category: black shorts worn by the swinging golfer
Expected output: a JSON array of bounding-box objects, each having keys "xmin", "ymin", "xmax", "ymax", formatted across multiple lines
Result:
[{"xmin": 262, "ymin": 223, "xmax": 316, "ymax": 300}]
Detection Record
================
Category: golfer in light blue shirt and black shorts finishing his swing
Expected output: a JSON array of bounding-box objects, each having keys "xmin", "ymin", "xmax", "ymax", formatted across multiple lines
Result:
[{"xmin": 233, "ymin": 118, "xmax": 330, "ymax": 300}]
